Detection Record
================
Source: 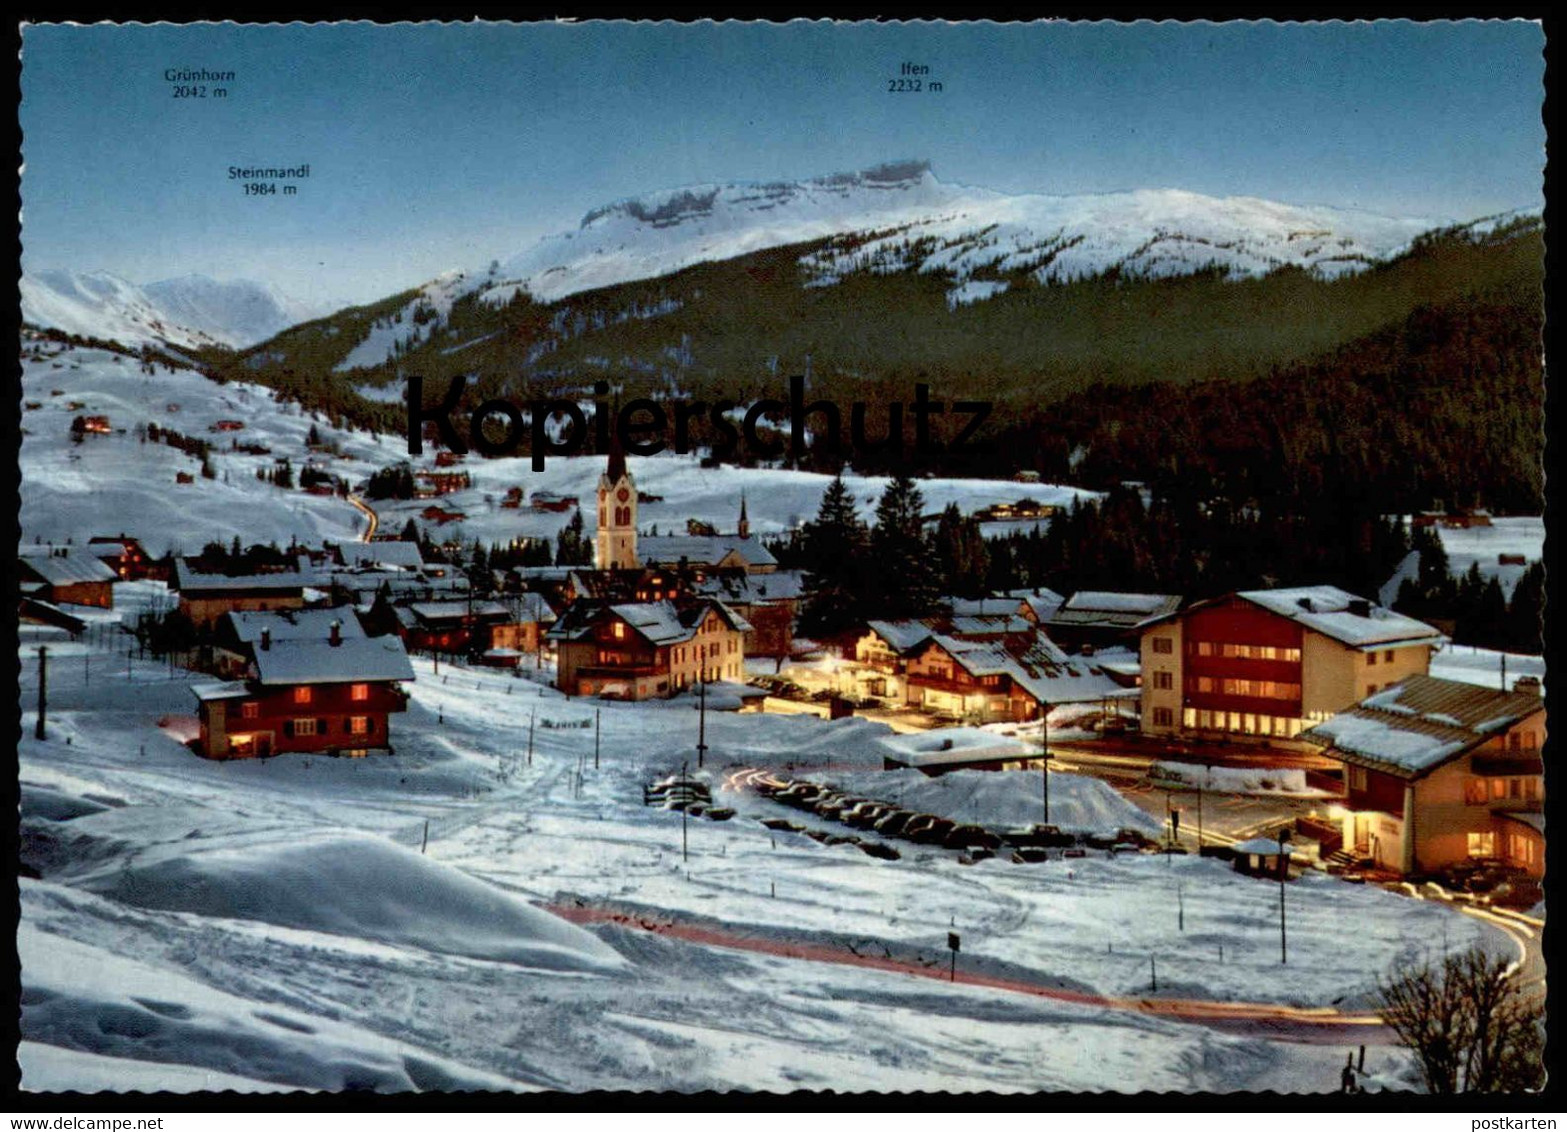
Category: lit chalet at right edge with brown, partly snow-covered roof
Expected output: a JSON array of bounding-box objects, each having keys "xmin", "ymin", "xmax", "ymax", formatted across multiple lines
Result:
[{"xmin": 1302, "ymin": 676, "xmax": 1545, "ymax": 878}]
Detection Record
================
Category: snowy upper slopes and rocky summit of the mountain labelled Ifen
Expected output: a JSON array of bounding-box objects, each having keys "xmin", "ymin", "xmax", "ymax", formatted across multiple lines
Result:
[{"xmin": 340, "ymin": 161, "xmax": 1449, "ymax": 368}]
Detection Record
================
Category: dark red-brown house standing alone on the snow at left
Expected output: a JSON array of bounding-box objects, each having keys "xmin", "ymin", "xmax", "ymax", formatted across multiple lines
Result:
[{"xmin": 191, "ymin": 632, "xmax": 414, "ymax": 759}]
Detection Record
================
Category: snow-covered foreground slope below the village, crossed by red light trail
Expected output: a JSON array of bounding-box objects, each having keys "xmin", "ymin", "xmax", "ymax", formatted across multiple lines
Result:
[{"xmin": 17, "ymin": 630, "xmax": 1507, "ymax": 1091}]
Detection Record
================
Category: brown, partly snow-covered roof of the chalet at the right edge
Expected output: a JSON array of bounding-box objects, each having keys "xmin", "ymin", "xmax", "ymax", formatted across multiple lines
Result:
[{"xmin": 1301, "ymin": 676, "xmax": 1545, "ymax": 778}]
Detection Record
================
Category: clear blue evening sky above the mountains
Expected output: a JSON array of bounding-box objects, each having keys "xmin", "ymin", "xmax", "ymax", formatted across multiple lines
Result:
[{"xmin": 20, "ymin": 20, "xmax": 1545, "ymax": 301}]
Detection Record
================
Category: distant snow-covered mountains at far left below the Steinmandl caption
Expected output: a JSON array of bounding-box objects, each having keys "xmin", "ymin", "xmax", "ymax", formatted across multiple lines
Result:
[{"xmin": 22, "ymin": 270, "xmax": 324, "ymax": 346}]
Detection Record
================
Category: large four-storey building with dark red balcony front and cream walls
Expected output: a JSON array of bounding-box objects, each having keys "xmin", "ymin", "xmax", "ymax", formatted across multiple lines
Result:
[{"xmin": 1139, "ymin": 586, "xmax": 1443, "ymax": 746}]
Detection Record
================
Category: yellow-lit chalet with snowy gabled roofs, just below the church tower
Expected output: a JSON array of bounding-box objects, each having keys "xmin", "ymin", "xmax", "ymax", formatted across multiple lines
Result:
[{"xmin": 545, "ymin": 597, "xmax": 751, "ymax": 699}]
